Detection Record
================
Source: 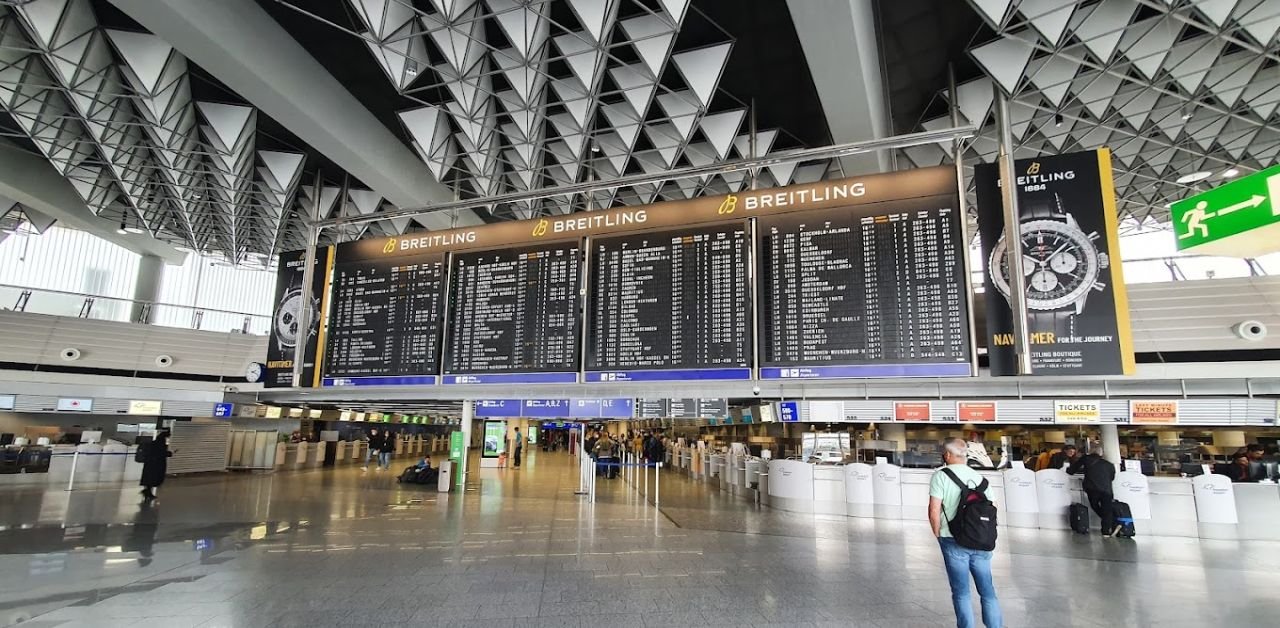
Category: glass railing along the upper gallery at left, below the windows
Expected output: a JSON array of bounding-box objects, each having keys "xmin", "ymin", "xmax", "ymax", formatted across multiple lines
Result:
[{"xmin": 0, "ymin": 284, "xmax": 271, "ymax": 335}]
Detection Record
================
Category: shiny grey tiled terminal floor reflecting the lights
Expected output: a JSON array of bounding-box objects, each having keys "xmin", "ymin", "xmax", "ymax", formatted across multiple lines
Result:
[{"xmin": 0, "ymin": 453, "xmax": 1280, "ymax": 628}]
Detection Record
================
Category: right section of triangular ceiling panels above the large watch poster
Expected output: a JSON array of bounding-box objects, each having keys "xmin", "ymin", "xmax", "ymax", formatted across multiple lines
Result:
[{"xmin": 902, "ymin": 0, "xmax": 1280, "ymax": 234}]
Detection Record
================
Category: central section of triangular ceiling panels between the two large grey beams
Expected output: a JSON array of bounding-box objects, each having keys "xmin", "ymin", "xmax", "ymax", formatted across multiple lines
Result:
[{"xmin": 299, "ymin": 0, "xmax": 826, "ymax": 223}]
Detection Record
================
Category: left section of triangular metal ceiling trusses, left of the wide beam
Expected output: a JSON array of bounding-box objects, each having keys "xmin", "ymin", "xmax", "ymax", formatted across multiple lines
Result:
[{"xmin": 0, "ymin": 0, "xmax": 303, "ymax": 263}]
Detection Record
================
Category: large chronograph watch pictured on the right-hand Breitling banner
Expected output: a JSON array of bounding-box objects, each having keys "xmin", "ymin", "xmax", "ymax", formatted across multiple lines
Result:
[{"xmin": 987, "ymin": 196, "xmax": 1110, "ymax": 313}]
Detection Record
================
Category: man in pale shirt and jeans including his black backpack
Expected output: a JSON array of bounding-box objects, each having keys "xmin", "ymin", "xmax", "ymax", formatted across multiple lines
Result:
[{"xmin": 929, "ymin": 439, "xmax": 1005, "ymax": 628}]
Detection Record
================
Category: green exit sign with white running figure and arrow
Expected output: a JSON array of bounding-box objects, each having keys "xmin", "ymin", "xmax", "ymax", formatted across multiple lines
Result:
[{"xmin": 1169, "ymin": 165, "xmax": 1280, "ymax": 257}]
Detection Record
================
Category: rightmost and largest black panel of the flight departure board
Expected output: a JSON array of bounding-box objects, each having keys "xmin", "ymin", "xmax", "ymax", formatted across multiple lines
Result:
[{"xmin": 756, "ymin": 196, "xmax": 973, "ymax": 379}]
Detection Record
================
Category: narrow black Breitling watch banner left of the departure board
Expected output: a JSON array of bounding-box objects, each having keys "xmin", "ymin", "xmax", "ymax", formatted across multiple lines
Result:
[{"xmin": 262, "ymin": 247, "xmax": 333, "ymax": 388}]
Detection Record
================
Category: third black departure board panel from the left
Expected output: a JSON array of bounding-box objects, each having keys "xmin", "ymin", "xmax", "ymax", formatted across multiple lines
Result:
[{"xmin": 586, "ymin": 221, "xmax": 753, "ymax": 381}]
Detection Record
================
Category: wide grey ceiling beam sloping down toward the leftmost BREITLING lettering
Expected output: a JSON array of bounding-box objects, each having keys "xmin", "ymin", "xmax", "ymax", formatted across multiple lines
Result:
[{"xmin": 111, "ymin": 0, "xmax": 480, "ymax": 229}]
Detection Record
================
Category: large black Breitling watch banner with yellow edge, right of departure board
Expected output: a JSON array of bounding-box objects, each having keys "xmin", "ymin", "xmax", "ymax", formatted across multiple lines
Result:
[{"xmin": 975, "ymin": 148, "xmax": 1134, "ymax": 375}]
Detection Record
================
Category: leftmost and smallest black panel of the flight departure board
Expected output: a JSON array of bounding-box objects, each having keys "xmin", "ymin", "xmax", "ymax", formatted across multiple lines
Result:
[{"xmin": 324, "ymin": 247, "xmax": 445, "ymax": 386}]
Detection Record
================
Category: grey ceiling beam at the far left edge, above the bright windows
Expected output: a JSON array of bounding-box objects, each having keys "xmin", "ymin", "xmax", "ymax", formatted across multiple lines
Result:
[{"xmin": 0, "ymin": 139, "xmax": 187, "ymax": 263}]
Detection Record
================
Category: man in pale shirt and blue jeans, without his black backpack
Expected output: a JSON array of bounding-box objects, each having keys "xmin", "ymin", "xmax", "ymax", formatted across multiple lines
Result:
[{"xmin": 929, "ymin": 439, "xmax": 1005, "ymax": 628}]
